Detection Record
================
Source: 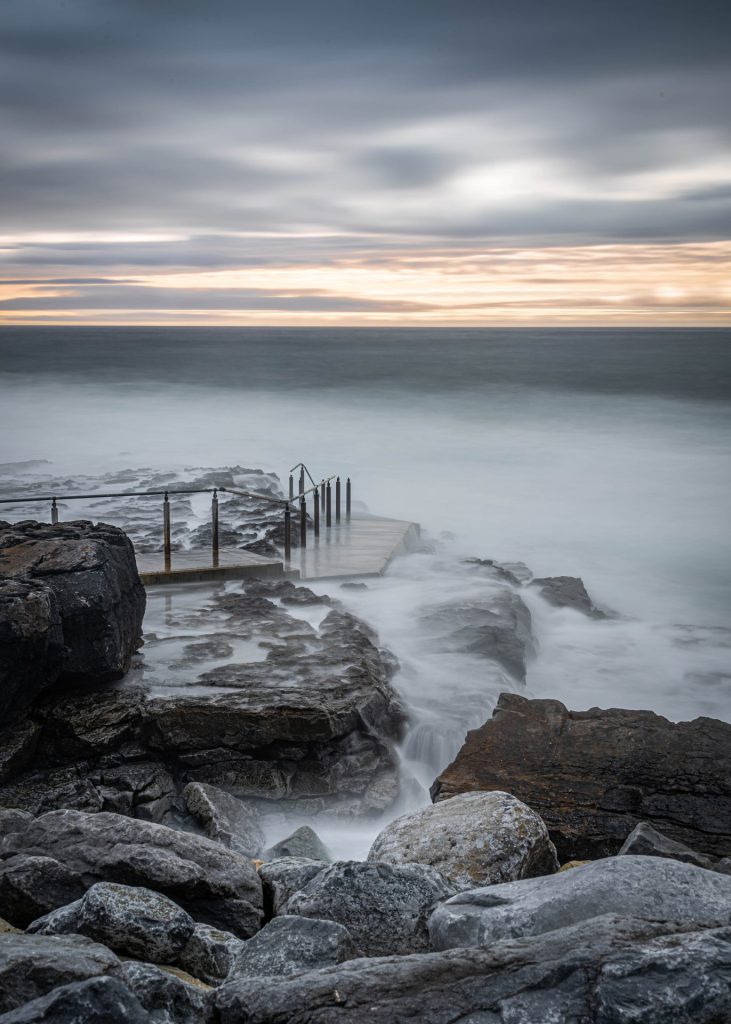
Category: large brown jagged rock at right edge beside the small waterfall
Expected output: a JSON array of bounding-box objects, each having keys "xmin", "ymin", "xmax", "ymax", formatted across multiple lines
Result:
[{"xmin": 432, "ymin": 693, "xmax": 731, "ymax": 861}]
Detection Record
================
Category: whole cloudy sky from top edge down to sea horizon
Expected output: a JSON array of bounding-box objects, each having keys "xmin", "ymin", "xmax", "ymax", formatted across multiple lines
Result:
[{"xmin": 0, "ymin": 0, "xmax": 731, "ymax": 326}]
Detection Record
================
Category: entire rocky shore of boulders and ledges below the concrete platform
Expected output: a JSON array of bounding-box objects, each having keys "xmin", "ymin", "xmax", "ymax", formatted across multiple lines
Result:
[{"xmin": 0, "ymin": 523, "xmax": 731, "ymax": 1024}]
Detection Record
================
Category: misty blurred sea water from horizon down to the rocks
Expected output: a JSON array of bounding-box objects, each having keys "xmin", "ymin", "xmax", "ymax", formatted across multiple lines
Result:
[{"xmin": 0, "ymin": 329, "xmax": 731, "ymax": 745}]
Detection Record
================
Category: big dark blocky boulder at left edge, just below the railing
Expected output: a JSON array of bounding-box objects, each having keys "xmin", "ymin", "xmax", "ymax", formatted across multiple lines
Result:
[{"xmin": 0, "ymin": 521, "xmax": 145, "ymax": 721}]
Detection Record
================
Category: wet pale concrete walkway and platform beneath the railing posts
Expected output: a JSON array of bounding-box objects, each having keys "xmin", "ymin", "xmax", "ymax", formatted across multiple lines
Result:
[{"xmin": 137, "ymin": 515, "xmax": 419, "ymax": 587}]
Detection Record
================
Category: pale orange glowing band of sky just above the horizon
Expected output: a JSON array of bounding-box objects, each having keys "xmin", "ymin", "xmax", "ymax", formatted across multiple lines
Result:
[{"xmin": 0, "ymin": 240, "xmax": 731, "ymax": 327}]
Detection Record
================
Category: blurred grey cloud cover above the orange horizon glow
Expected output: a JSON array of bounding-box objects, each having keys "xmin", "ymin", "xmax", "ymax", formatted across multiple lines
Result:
[{"xmin": 0, "ymin": 0, "xmax": 731, "ymax": 319}]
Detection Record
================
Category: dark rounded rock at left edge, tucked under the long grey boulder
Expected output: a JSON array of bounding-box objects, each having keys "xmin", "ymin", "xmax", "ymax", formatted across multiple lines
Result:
[{"xmin": 0, "ymin": 856, "xmax": 86, "ymax": 928}]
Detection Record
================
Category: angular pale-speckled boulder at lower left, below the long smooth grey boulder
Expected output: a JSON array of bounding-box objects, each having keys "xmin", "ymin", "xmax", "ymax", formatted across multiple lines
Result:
[{"xmin": 43, "ymin": 882, "xmax": 195, "ymax": 964}]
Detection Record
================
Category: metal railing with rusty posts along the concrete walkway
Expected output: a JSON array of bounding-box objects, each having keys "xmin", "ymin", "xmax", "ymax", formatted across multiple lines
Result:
[{"xmin": 0, "ymin": 463, "xmax": 351, "ymax": 572}]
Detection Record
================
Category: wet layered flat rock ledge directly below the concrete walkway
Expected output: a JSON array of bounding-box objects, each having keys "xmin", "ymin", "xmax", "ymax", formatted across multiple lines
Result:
[{"xmin": 0, "ymin": 580, "xmax": 404, "ymax": 819}]
